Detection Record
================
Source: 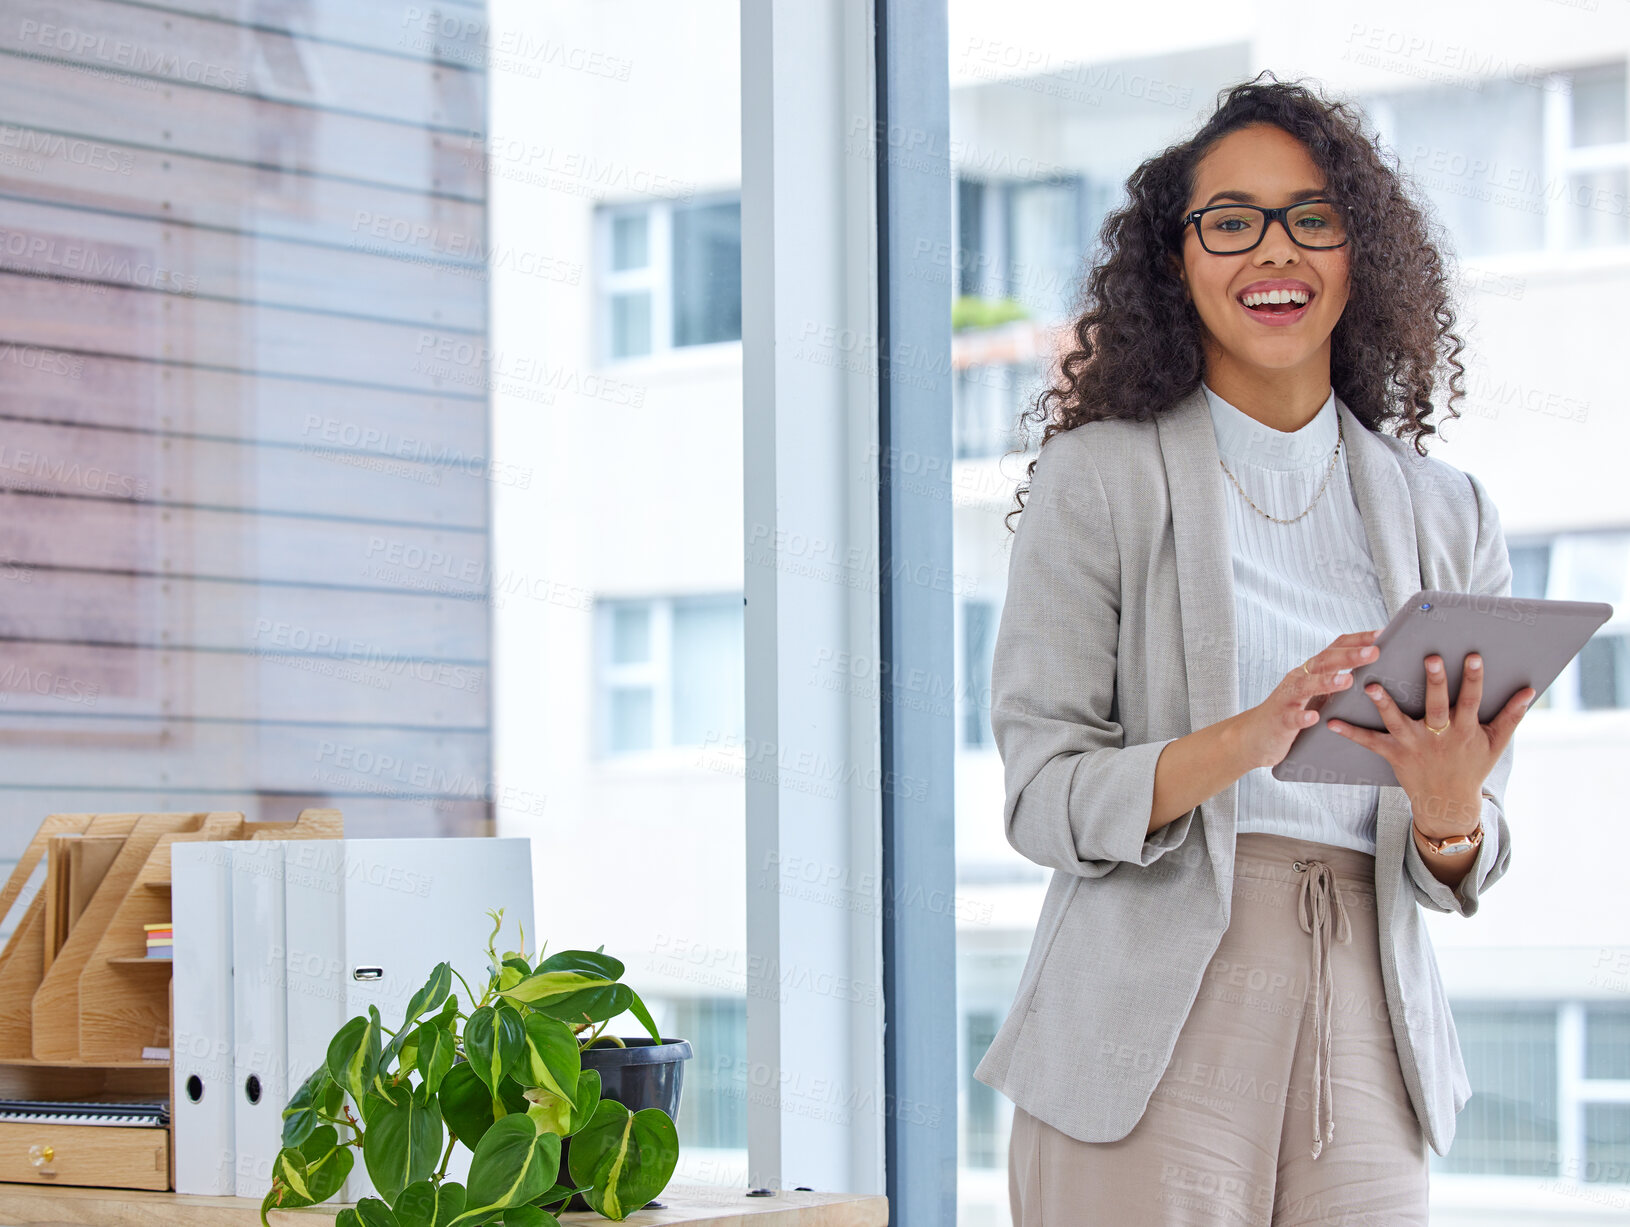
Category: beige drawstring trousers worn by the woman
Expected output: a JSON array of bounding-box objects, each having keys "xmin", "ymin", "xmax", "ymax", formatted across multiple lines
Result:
[{"xmin": 1007, "ymin": 831, "xmax": 1428, "ymax": 1227}]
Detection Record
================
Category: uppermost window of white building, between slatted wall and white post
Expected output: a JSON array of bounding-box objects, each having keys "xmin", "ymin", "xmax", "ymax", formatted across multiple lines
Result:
[{"xmin": 600, "ymin": 196, "xmax": 742, "ymax": 362}]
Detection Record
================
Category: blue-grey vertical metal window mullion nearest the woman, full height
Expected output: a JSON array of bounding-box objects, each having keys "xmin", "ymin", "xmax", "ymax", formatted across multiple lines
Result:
[{"xmin": 872, "ymin": 0, "xmax": 951, "ymax": 1227}]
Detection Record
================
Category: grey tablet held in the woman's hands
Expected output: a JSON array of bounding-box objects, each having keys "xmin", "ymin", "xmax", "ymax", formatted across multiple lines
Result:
[{"xmin": 1273, "ymin": 590, "xmax": 1614, "ymax": 787}]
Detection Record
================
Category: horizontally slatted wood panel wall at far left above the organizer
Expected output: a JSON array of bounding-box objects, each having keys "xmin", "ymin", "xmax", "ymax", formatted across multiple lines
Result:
[{"xmin": 0, "ymin": 0, "xmax": 495, "ymax": 859}]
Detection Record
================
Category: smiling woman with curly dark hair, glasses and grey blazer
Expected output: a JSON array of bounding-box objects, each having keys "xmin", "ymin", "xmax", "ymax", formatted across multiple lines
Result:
[{"xmin": 975, "ymin": 77, "xmax": 1534, "ymax": 1227}]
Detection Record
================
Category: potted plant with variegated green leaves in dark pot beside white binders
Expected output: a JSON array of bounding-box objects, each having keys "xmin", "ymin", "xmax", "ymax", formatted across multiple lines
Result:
[{"xmin": 261, "ymin": 911, "xmax": 691, "ymax": 1227}]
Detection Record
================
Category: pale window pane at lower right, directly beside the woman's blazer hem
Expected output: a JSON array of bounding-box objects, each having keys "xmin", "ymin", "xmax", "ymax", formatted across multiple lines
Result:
[{"xmin": 1431, "ymin": 1002, "xmax": 1560, "ymax": 1176}]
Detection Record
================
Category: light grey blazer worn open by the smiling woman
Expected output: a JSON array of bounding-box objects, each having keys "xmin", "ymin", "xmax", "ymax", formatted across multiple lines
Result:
[{"xmin": 975, "ymin": 386, "xmax": 1514, "ymax": 1155}]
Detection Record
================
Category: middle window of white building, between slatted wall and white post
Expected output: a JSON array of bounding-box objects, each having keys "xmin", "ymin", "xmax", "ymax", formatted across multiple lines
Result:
[{"xmin": 598, "ymin": 593, "xmax": 745, "ymax": 756}]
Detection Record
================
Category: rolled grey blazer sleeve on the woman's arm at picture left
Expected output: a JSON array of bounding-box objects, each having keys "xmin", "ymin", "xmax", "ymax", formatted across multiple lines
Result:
[{"xmin": 991, "ymin": 435, "xmax": 1198, "ymax": 878}]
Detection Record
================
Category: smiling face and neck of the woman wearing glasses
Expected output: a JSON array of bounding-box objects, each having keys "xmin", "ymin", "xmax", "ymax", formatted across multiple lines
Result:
[{"xmin": 1174, "ymin": 124, "xmax": 1351, "ymax": 412}]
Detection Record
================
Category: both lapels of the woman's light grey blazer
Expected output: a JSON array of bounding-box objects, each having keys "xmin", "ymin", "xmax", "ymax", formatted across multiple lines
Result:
[{"xmin": 1156, "ymin": 385, "xmax": 1421, "ymax": 893}]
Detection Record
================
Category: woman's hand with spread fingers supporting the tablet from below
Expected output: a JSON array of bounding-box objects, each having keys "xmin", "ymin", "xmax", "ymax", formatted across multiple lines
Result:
[{"xmin": 1325, "ymin": 652, "xmax": 1535, "ymax": 838}]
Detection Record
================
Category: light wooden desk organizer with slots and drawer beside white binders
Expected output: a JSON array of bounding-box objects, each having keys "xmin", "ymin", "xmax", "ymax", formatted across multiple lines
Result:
[{"xmin": 0, "ymin": 810, "xmax": 344, "ymax": 1190}]
